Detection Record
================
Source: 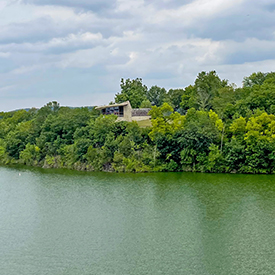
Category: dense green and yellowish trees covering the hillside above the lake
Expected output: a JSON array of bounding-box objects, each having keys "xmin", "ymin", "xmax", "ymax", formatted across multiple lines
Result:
[{"xmin": 0, "ymin": 71, "xmax": 275, "ymax": 173}]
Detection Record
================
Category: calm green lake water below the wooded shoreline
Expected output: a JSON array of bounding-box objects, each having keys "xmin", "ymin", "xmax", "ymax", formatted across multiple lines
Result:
[{"xmin": 0, "ymin": 167, "xmax": 275, "ymax": 275}]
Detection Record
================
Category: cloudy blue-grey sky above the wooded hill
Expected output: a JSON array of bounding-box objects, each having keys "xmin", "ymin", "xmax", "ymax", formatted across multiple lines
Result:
[{"xmin": 0, "ymin": 0, "xmax": 275, "ymax": 111}]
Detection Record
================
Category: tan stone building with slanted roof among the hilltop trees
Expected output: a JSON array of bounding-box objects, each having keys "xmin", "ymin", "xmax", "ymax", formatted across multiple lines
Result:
[{"xmin": 96, "ymin": 101, "xmax": 151, "ymax": 122}]
